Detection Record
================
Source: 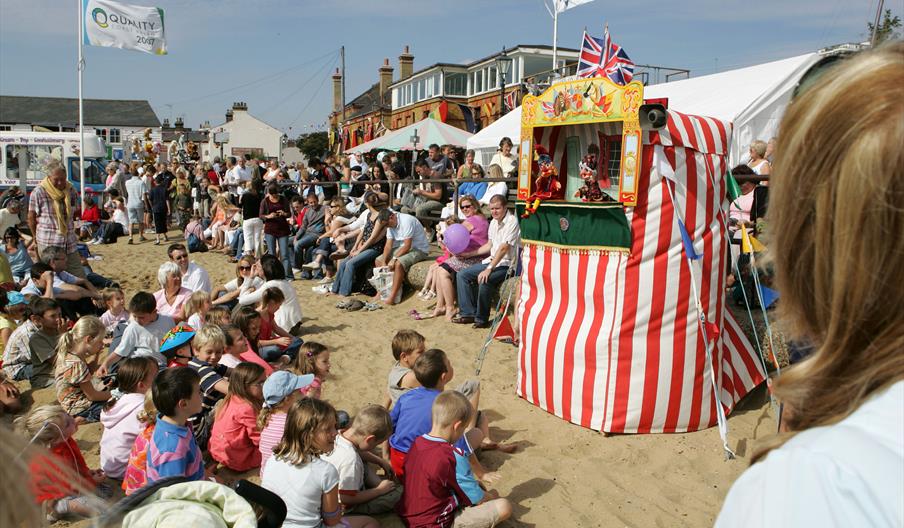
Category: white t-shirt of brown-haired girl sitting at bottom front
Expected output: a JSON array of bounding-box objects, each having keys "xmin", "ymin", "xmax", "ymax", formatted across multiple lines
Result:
[{"xmin": 261, "ymin": 456, "xmax": 339, "ymax": 528}]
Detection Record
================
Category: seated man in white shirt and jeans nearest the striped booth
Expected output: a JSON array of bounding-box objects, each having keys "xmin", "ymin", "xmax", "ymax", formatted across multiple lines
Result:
[{"xmin": 452, "ymin": 194, "xmax": 521, "ymax": 328}]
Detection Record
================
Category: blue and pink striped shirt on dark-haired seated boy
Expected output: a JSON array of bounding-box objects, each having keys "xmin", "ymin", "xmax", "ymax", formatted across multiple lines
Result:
[{"xmin": 147, "ymin": 414, "xmax": 204, "ymax": 484}]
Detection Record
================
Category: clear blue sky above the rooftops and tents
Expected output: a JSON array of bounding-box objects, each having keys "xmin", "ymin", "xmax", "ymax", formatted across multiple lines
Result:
[{"xmin": 0, "ymin": 0, "xmax": 888, "ymax": 136}]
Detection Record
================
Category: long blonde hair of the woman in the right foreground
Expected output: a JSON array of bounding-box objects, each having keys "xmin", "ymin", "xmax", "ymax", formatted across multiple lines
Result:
[{"xmin": 753, "ymin": 42, "xmax": 904, "ymax": 462}]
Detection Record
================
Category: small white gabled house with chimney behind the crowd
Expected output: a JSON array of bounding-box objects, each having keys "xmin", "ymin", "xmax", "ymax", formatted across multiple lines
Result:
[{"xmin": 201, "ymin": 103, "xmax": 283, "ymax": 160}]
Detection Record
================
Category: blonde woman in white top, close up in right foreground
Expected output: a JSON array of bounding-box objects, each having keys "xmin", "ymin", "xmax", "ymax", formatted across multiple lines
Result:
[{"xmin": 716, "ymin": 42, "xmax": 904, "ymax": 527}]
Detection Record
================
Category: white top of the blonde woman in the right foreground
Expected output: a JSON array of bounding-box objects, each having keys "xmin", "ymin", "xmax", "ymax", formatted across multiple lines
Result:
[{"xmin": 716, "ymin": 381, "xmax": 904, "ymax": 528}]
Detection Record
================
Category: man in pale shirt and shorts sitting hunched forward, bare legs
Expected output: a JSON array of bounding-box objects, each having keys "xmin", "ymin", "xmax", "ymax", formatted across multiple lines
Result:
[{"xmin": 375, "ymin": 209, "xmax": 430, "ymax": 305}]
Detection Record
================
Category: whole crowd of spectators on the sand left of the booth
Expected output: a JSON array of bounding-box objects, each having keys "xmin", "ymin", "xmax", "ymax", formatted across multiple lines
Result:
[{"xmin": 0, "ymin": 137, "xmax": 519, "ymax": 526}]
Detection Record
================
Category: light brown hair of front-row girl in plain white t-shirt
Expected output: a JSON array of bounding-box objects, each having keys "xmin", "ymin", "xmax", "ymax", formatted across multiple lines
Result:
[{"xmin": 273, "ymin": 398, "xmax": 336, "ymax": 465}]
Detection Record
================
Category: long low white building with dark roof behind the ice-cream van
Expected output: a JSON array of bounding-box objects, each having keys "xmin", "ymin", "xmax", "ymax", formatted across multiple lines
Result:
[{"xmin": 0, "ymin": 95, "xmax": 160, "ymax": 159}]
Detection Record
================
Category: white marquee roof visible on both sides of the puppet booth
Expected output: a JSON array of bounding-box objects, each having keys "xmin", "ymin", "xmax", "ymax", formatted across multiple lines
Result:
[{"xmin": 468, "ymin": 53, "xmax": 820, "ymax": 164}]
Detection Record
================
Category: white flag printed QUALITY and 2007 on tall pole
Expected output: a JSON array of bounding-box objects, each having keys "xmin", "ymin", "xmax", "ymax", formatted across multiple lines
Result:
[{"xmin": 82, "ymin": 0, "xmax": 166, "ymax": 55}]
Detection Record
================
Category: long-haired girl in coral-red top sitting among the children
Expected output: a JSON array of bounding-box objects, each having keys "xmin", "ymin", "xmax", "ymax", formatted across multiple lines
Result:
[{"xmin": 209, "ymin": 362, "xmax": 266, "ymax": 472}]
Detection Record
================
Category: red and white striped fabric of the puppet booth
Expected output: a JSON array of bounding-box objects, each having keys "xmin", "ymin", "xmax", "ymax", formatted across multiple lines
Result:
[{"xmin": 517, "ymin": 111, "xmax": 764, "ymax": 433}]
